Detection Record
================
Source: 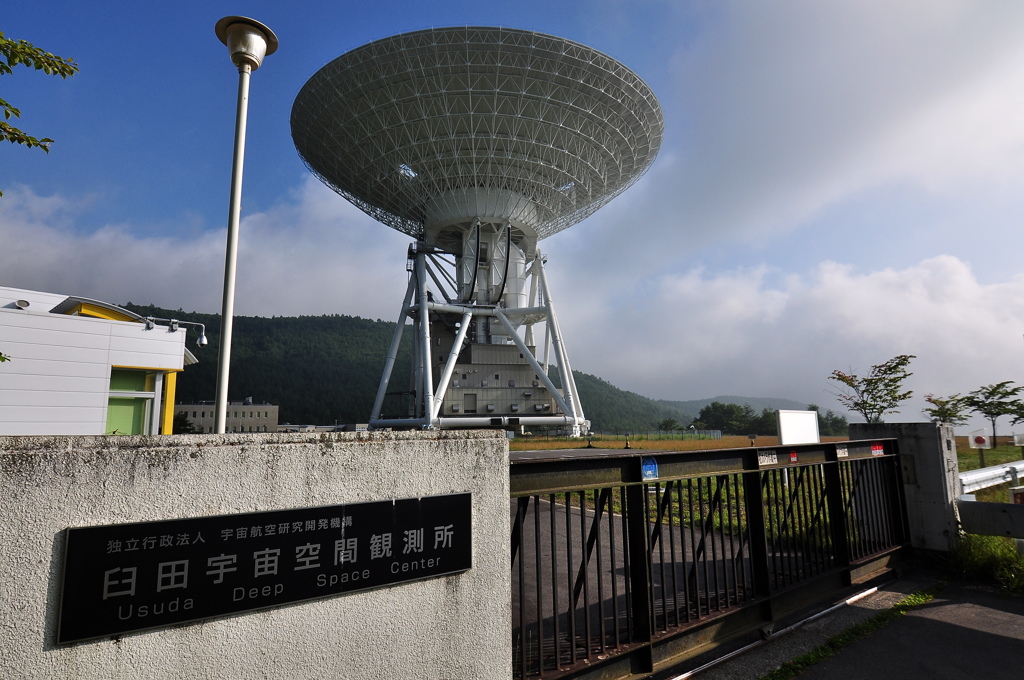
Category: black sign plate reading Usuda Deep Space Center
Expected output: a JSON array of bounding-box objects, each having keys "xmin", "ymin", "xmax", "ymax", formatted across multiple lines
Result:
[{"xmin": 57, "ymin": 494, "xmax": 472, "ymax": 644}]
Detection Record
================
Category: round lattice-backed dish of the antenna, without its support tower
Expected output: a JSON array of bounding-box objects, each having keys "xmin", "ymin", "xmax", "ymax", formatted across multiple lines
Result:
[{"xmin": 292, "ymin": 28, "xmax": 664, "ymax": 239}]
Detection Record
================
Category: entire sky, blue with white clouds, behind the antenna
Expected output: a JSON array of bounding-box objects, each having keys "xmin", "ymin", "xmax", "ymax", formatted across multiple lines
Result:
[{"xmin": 6, "ymin": 0, "xmax": 1024, "ymax": 429}]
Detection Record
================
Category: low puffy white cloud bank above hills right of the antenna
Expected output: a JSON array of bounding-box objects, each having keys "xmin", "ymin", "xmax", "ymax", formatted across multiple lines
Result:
[{"xmin": 560, "ymin": 256, "xmax": 1024, "ymax": 421}]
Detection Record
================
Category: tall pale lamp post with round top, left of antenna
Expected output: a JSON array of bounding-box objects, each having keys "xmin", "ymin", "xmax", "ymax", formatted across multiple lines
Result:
[{"xmin": 214, "ymin": 16, "xmax": 278, "ymax": 434}]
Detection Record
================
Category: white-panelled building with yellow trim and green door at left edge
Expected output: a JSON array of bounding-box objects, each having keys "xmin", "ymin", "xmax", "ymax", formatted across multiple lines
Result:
[{"xmin": 0, "ymin": 287, "xmax": 198, "ymax": 435}]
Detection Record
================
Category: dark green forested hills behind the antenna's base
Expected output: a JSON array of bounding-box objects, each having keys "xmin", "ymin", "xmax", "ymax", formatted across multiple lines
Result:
[{"xmin": 124, "ymin": 302, "xmax": 819, "ymax": 432}]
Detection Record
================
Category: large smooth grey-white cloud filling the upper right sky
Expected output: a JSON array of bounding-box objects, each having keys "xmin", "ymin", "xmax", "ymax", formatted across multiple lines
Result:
[{"xmin": 577, "ymin": 0, "xmax": 1024, "ymax": 264}]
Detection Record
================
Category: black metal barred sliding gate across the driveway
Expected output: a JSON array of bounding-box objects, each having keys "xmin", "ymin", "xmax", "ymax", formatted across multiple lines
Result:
[{"xmin": 511, "ymin": 440, "xmax": 906, "ymax": 679}]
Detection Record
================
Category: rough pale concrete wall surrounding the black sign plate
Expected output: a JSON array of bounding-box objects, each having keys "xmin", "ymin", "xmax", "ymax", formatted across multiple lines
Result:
[{"xmin": 0, "ymin": 431, "xmax": 511, "ymax": 680}]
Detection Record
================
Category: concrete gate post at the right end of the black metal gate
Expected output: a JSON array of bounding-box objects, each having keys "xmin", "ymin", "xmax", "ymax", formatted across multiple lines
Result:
[{"xmin": 850, "ymin": 423, "xmax": 959, "ymax": 552}]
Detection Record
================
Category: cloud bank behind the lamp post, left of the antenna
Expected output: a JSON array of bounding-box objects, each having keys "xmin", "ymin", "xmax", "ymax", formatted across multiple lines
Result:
[{"xmin": 0, "ymin": 177, "xmax": 408, "ymax": 318}]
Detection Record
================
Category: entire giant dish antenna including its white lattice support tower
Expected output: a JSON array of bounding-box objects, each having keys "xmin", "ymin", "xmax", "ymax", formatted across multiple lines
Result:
[{"xmin": 291, "ymin": 27, "xmax": 664, "ymax": 436}]
